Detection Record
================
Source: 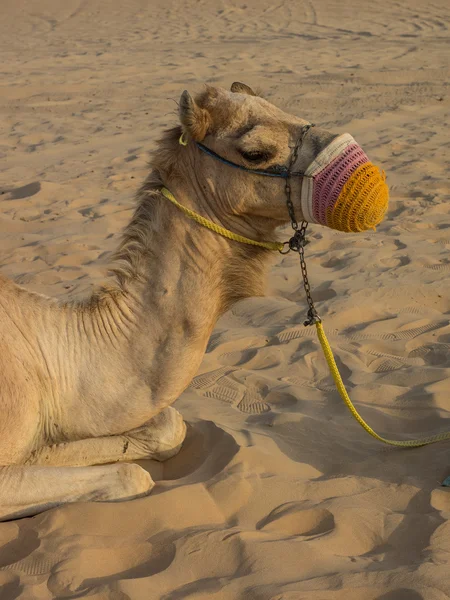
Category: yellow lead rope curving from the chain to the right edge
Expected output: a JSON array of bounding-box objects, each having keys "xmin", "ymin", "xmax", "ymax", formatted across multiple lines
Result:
[{"xmin": 316, "ymin": 322, "xmax": 450, "ymax": 448}]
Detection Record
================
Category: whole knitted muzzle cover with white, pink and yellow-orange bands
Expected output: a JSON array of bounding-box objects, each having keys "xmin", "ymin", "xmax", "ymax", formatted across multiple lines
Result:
[{"xmin": 301, "ymin": 133, "xmax": 389, "ymax": 232}]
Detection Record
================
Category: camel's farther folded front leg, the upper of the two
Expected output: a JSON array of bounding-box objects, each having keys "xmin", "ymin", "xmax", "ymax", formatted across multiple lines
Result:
[{"xmin": 26, "ymin": 406, "xmax": 186, "ymax": 467}]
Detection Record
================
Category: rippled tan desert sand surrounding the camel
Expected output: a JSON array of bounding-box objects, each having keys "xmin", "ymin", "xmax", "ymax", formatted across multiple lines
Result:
[{"xmin": 0, "ymin": 0, "xmax": 450, "ymax": 600}]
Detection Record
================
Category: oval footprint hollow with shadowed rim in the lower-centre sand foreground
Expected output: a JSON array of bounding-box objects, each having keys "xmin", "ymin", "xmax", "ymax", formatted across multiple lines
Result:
[{"xmin": 257, "ymin": 502, "xmax": 335, "ymax": 536}]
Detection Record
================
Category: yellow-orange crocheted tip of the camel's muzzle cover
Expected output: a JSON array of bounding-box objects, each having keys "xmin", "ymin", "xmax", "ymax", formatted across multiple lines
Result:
[{"xmin": 327, "ymin": 162, "xmax": 389, "ymax": 233}]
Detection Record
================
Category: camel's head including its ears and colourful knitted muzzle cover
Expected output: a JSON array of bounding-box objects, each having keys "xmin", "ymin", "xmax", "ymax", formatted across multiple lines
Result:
[{"xmin": 174, "ymin": 83, "xmax": 387, "ymax": 236}]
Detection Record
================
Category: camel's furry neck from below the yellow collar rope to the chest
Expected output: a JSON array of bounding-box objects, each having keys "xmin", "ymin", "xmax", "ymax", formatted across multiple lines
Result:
[{"xmin": 89, "ymin": 185, "xmax": 272, "ymax": 403}]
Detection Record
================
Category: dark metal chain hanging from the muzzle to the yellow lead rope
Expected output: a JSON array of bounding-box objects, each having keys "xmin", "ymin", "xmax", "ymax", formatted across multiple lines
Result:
[{"xmin": 281, "ymin": 124, "xmax": 320, "ymax": 327}]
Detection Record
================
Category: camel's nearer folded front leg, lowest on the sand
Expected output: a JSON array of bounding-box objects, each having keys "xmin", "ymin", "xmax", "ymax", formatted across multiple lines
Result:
[{"xmin": 0, "ymin": 464, "xmax": 154, "ymax": 521}]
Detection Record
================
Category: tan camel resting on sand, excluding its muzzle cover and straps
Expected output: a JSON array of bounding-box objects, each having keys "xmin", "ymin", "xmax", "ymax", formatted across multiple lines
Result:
[{"xmin": 0, "ymin": 83, "xmax": 336, "ymax": 520}]
